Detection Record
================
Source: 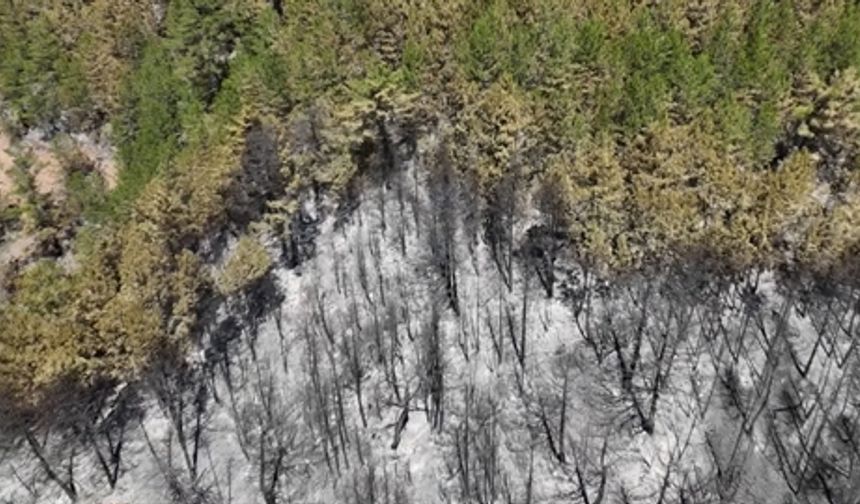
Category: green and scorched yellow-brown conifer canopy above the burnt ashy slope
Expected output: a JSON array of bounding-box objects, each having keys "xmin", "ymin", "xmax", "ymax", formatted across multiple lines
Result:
[{"xmin": 0, "ymin": 0, "xmax": 860, "ymax": 418}]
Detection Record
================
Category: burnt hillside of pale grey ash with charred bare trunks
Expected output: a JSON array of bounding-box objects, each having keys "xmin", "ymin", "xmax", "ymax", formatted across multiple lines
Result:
[{"xmin": 2, "ymin": 122, "xmax": 858, "ymax": 503}]
